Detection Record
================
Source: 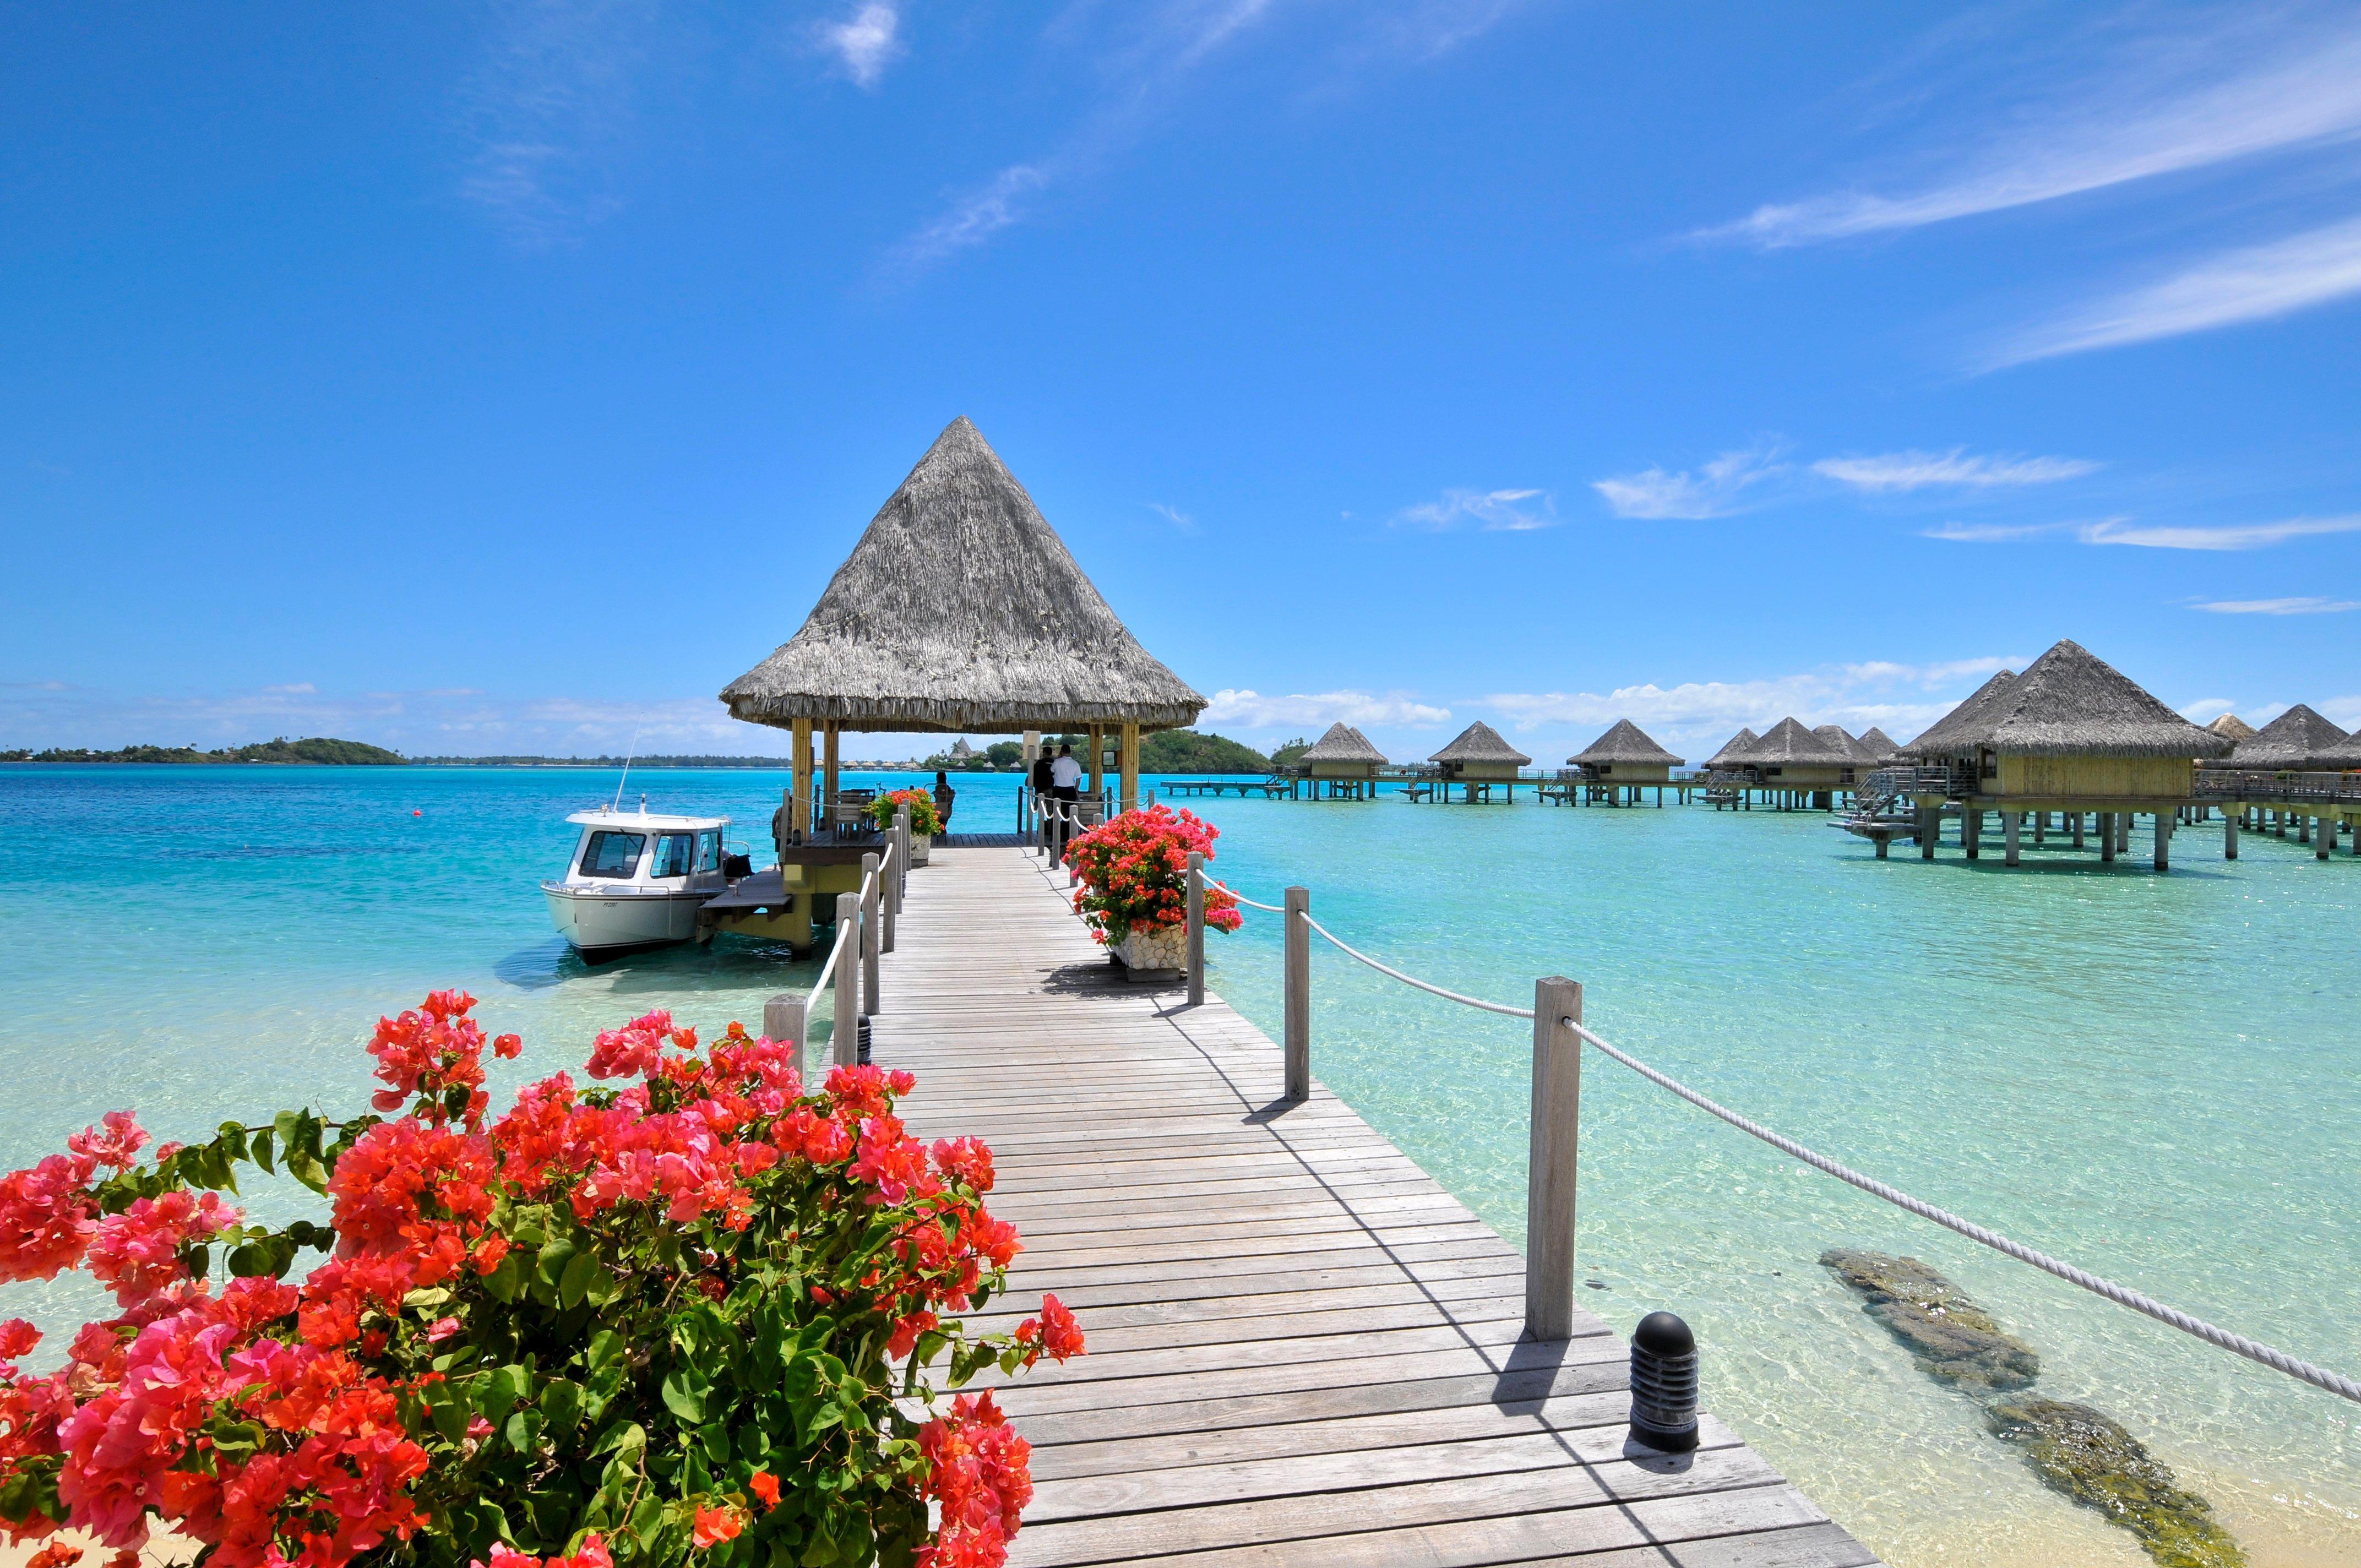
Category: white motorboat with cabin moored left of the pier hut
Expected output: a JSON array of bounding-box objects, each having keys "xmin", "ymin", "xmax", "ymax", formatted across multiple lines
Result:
[{"xmin": 541, "ymin": 796, "xmax": 730, "ymax": 959}]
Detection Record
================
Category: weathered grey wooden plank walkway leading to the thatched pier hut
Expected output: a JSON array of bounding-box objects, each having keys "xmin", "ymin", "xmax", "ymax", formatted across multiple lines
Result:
[{"xmin": 874, "ymin": 846, "xmax": 1875, "ymax": 1568}]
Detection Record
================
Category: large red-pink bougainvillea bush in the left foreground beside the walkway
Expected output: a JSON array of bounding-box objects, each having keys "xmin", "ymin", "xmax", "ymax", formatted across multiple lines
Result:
[{"xmin": 0, "ymin": 992, "xmax": 1081, "ymax": 1568}]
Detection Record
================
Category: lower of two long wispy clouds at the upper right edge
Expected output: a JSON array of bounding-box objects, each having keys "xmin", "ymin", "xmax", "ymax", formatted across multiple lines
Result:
[{"xmin": 1985, "ymin": 217, "xmax": 2361, "ymax": 368}]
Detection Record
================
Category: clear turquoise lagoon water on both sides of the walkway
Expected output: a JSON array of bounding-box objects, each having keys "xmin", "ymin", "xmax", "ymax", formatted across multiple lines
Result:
[{"xmin": 0, "ymin": 767, "xmax": 2361, "ymax": 1566}]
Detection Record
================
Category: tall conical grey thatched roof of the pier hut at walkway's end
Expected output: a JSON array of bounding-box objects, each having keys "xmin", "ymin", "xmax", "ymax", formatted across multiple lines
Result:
[{"xmin": 722, "ymin": 418, "xmax": 1204, "ymax": 732}]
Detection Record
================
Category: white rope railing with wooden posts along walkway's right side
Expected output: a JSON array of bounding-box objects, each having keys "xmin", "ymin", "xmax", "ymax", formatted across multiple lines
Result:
[{"xmin": 1188, "ymin": 852, "xmax": 2361, "ymax": 1403}]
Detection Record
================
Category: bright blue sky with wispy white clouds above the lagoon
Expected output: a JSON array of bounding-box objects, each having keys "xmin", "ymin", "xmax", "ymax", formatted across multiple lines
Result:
[{"xmin": 0, "ymin": 0, "xmax": 2361, "ymax": 763}]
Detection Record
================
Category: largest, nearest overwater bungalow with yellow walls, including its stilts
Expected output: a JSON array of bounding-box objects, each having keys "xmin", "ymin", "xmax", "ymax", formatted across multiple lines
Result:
[{"xmin": 1910, "ymin": 643, "xmax": 2231, "ymax": 872}]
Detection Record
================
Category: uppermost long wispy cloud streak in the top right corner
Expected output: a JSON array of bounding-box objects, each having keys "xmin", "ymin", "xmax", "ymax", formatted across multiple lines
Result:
[{"xmin": 1698, "ymin": 12, "xmax": 2361, "ymax": 248}]
